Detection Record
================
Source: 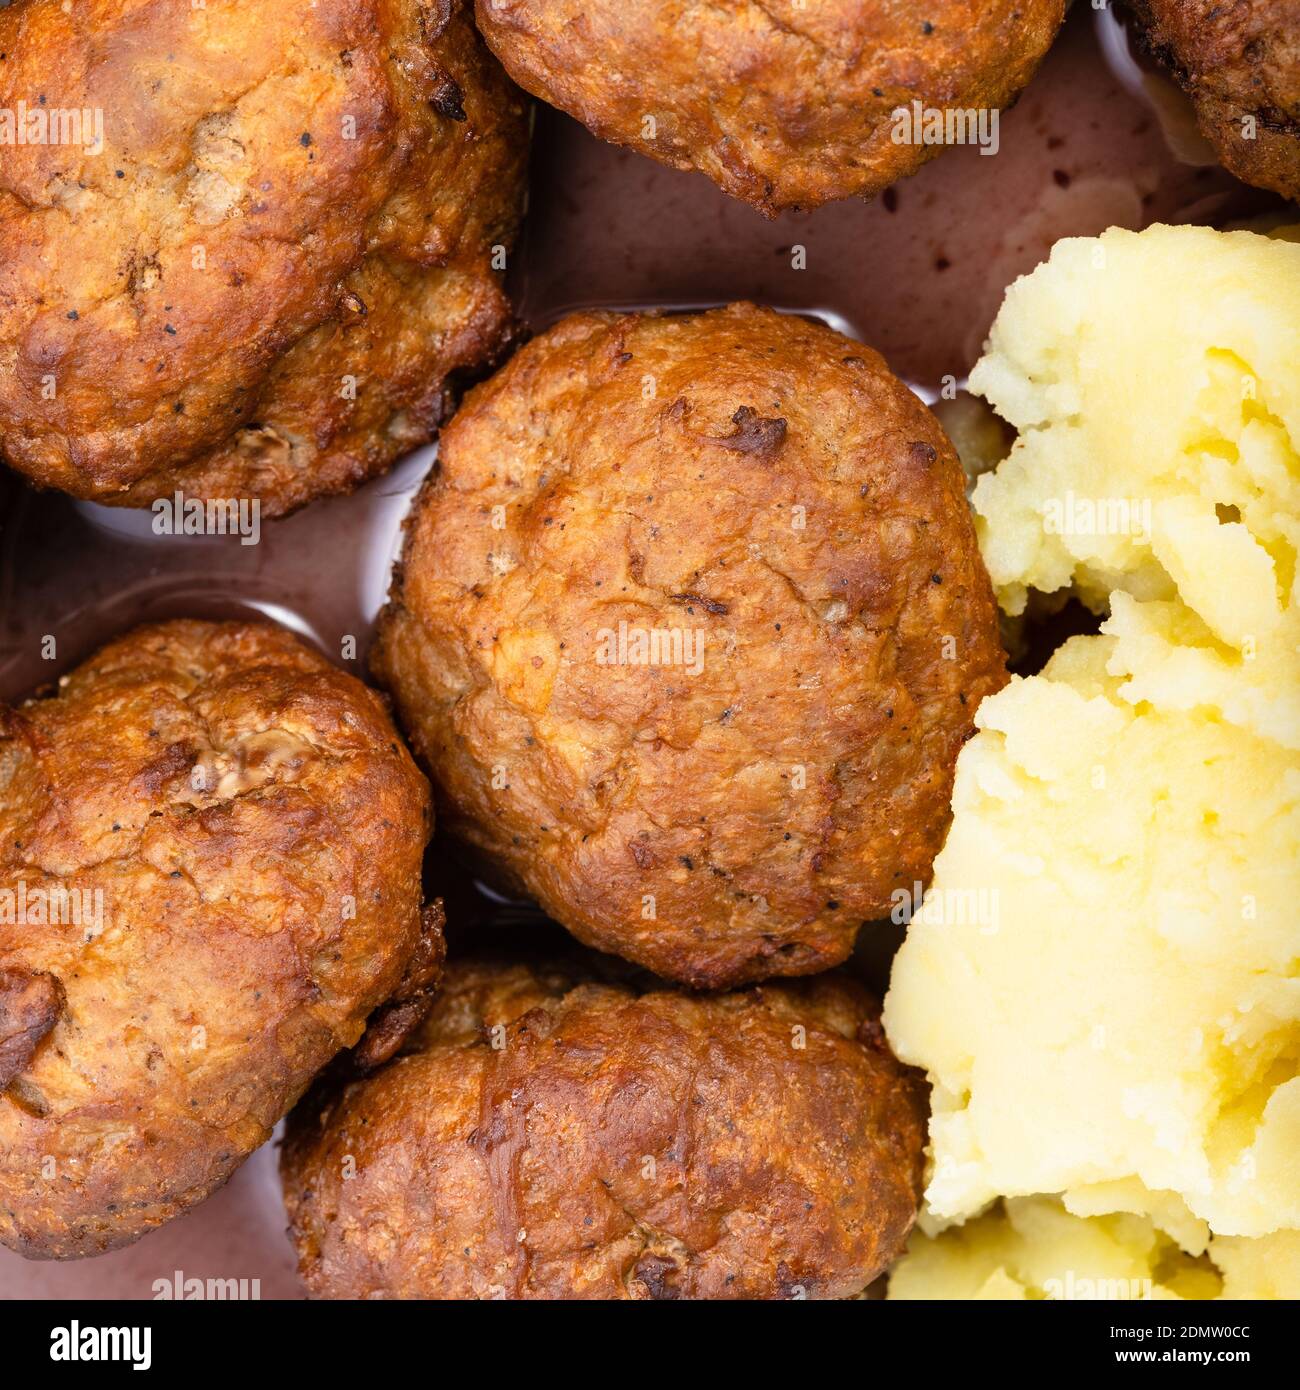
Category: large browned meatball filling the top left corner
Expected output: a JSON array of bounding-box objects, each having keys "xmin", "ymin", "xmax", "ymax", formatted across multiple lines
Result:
[{"xmin": 0, "ymin": 0, "xmax": 526, "ymax": 516}]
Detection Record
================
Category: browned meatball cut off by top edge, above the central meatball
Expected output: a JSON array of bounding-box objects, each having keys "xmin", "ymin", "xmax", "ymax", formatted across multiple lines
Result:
[{"xmin": 477, "ymin": 0, "xmax": 1065, "ymax": 217}]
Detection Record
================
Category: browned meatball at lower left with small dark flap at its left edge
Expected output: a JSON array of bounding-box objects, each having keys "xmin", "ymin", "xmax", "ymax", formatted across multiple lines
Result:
[{"xmin": 0, "ymin": 621, "xmax": 441, "ymax": 1259}]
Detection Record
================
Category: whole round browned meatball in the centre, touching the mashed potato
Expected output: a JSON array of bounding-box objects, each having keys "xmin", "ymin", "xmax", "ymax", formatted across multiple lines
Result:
[{"xmin": 373, "ymin": 304, "xmax": 1005, "ymax": 988}]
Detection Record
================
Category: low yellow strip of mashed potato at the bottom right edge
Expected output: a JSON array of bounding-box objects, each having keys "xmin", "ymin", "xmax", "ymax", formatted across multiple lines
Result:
[{"xmin": 888, "ymin": 1197, "xmax": 1300, "ymax": 1300}]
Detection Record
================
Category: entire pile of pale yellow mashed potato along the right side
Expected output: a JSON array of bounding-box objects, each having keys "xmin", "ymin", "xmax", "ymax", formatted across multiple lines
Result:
[{"xmin": 886, "ymin": 227, "xmax": 1300, "ymax": 1278}]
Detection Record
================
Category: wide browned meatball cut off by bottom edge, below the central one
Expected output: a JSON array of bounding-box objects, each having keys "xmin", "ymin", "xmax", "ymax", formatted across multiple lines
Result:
[{"xmin": 282, "ymin": 963, "xmax": 926, "ymax": 1298}]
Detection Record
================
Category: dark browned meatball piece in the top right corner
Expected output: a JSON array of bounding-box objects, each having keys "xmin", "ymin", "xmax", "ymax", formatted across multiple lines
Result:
[{"xmin": 1135, "ymin": 0, "xmax": 1300, "ymax": 199}]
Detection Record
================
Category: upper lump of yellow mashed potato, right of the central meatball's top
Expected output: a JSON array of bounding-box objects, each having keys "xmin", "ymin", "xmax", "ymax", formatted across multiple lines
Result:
[{"xmin": 970, "ymin": 227, "xmax": 1300, "ymax": 648}]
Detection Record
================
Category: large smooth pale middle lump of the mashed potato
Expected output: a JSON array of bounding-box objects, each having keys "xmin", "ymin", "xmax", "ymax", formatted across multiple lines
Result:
[{"xmin": 886, "ymin": 628, "xmax": 1300, "ymax": 1250}]
